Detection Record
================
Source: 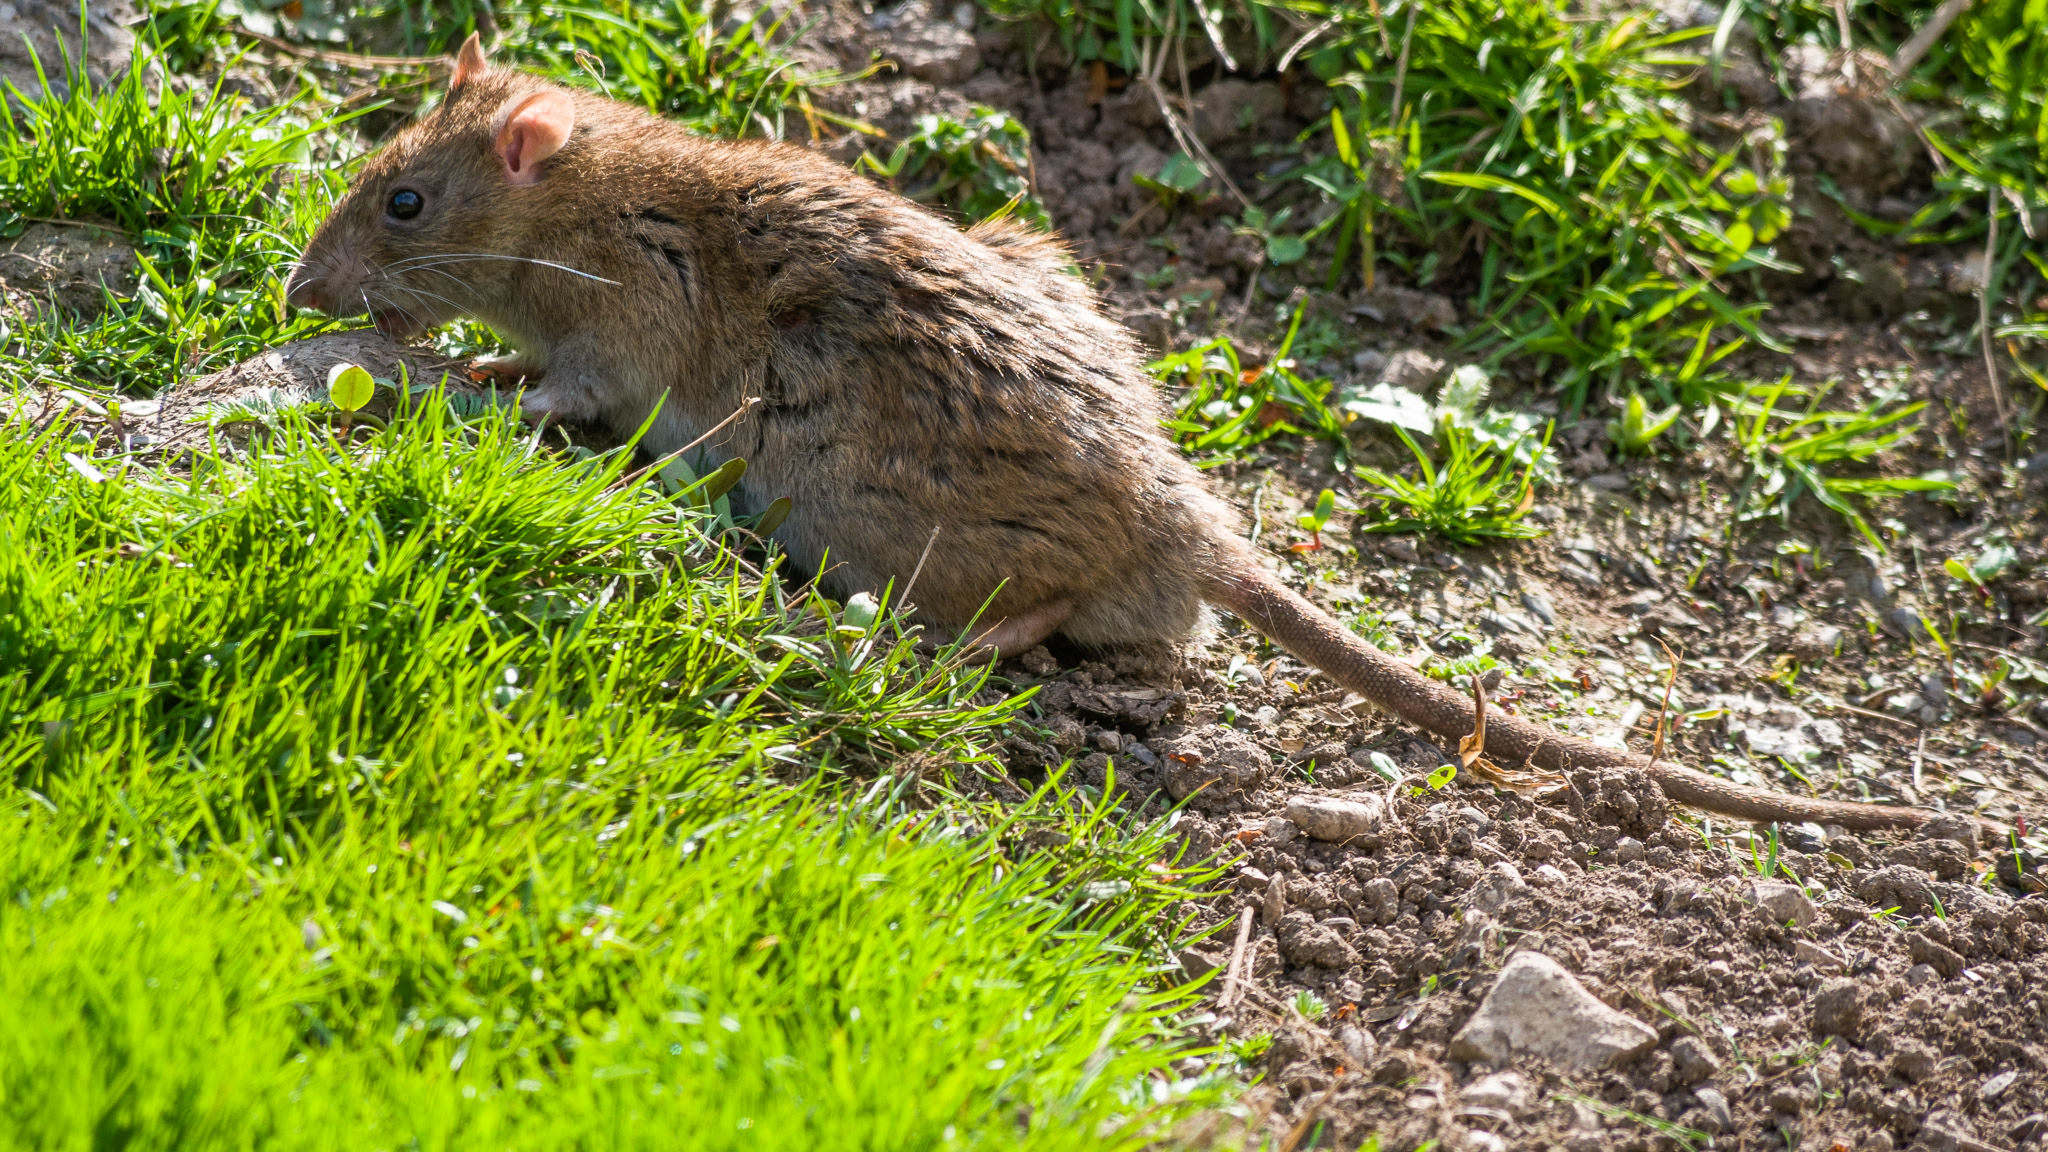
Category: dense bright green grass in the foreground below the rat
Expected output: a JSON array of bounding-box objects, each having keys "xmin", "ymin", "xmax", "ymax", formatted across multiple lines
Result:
[{"xmin": 0, "ymin": 400, "xmax": 1214, "ymax": 1148}]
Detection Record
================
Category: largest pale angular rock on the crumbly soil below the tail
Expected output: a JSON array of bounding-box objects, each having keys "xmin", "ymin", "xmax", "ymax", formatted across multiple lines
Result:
[{"xmin": 1450, "ymin": 951, "xmax": 1657, "ymax": 1072}]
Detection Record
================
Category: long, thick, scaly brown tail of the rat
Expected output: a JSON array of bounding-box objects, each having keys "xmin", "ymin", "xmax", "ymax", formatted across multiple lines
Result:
[{"xmin": 1206, "ymin": 564, "xmax": 1935, "ymax": 830}]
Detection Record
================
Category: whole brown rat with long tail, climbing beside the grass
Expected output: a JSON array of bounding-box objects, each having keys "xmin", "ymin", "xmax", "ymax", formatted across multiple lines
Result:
[{"xmin": 287, "ymin": 37, "xmax": 1933, "ymax": 830}]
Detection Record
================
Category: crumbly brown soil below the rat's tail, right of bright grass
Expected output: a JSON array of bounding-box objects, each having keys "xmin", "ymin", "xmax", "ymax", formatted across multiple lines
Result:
[{"xmin": 1010, "ymin": 623, "xmax": 2048, "ymax": 1150}]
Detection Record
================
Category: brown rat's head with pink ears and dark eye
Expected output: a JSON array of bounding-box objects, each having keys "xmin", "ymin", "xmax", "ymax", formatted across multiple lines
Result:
[{"xmin": 285, "ymin": 35, "xmax": 575, "ymax": 336}]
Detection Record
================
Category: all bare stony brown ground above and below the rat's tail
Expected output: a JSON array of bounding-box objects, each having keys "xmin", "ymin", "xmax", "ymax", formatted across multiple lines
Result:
[{"xmin": 786, "ymin": 2, "xmax": 2048, "ymax": 1152}]
